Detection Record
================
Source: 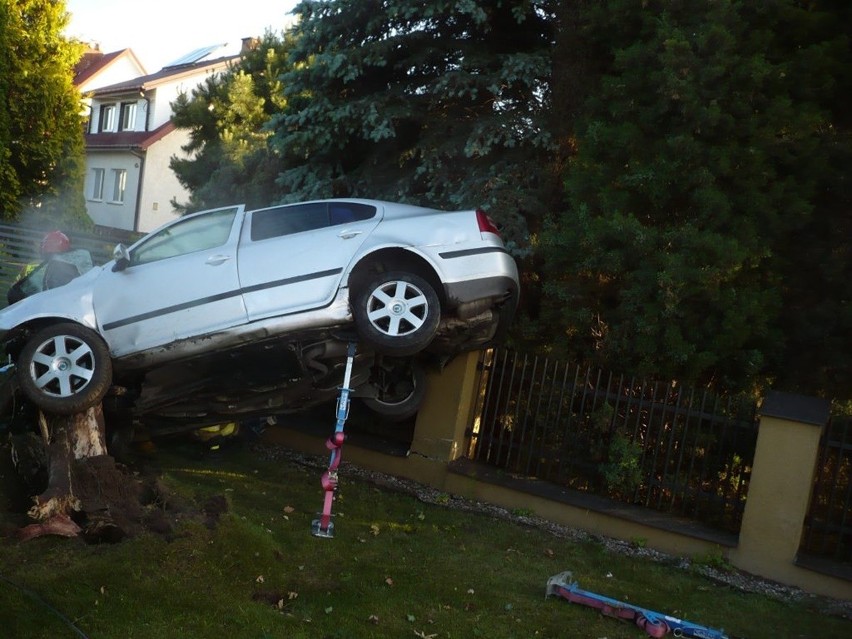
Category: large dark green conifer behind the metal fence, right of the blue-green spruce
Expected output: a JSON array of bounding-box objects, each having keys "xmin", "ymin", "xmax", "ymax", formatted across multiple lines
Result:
[{"xmin": 541, "ymin": 0, "xmax": 849, "ymax": 388}]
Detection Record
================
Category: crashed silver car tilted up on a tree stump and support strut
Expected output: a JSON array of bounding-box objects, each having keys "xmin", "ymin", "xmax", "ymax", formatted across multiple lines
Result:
[{"xmin": 0, "ymin": 200, "xmax": 518, "ymax": 423}]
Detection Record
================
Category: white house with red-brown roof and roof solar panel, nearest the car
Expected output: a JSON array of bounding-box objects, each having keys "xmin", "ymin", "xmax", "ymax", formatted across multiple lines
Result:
[{"xmin": 85, "ymin": 45, "xmax": 245, "ymax": 231}]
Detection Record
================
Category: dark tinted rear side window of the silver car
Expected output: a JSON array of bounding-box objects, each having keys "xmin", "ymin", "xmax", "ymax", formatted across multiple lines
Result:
[{"xmin": 251, "ymin": 202, "xmax": 376, "ymax": 242}]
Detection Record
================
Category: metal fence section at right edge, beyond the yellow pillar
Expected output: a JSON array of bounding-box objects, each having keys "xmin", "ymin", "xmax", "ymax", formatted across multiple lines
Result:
[{"xmin": 799, "ymin": 416, "xmax": 852, "ymax": 564}]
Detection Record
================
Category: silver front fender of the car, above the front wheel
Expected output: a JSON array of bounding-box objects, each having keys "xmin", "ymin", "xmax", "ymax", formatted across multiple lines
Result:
[{"xmin": 0, "ymin": 262, "xmax": 106, "ymax": 337}]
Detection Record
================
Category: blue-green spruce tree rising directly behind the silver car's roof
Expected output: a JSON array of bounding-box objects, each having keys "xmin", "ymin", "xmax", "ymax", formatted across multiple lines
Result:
[{"xmin": 271, "ymin": 0, "xmax": 558, "ymax": 243}]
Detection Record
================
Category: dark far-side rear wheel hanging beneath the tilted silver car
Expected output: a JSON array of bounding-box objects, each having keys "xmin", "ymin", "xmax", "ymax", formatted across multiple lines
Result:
[{"xmin": 361, "ymin": 360, "xmax": 426, "ymax": 422}]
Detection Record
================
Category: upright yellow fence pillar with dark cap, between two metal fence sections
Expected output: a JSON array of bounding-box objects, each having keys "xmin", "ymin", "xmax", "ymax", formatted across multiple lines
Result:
[{"xmin": 731, "ymin": 392, "xmax": 830, "ymax": 587}]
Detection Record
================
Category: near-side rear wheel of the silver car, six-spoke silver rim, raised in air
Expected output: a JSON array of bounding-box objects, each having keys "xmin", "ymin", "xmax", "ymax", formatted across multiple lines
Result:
[{"xmin": 352, "ymin": 271, "xmax": 441, "ymax": 357}]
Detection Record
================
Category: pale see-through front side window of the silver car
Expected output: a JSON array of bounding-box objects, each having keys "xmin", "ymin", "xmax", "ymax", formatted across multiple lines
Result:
[{"xmin": 130, "ymin": 207, "xmax": 238, "ymax": 266}]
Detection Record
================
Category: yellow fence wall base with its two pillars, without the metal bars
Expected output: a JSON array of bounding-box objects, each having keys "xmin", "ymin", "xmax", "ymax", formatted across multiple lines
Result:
[{"xmin": 268, "ymin": 353, "xmax": 852, "ymax": 600}]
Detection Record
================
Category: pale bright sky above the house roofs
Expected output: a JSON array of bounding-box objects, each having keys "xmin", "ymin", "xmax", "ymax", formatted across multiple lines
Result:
[{"xmin": 65, "ymin": 0, "xmax": 298, "ymax": 73}]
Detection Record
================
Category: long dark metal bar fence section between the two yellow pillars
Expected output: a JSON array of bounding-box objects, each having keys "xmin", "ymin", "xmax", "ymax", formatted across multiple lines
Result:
[{"xmin": 467, "ymin": 350, "xmax": 757, "ymax": 533}]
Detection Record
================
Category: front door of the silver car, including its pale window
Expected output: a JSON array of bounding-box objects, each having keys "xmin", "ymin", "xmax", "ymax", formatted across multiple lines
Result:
[{"xmin": 93, "ymin": 206, "xmax": 246, "ymax": 356}]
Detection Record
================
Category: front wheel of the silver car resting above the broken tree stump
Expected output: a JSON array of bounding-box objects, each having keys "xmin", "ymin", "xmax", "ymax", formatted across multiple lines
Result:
[{"xmin": 17, "ymin": 322, "xmax": 112, "ymax": 415}]
